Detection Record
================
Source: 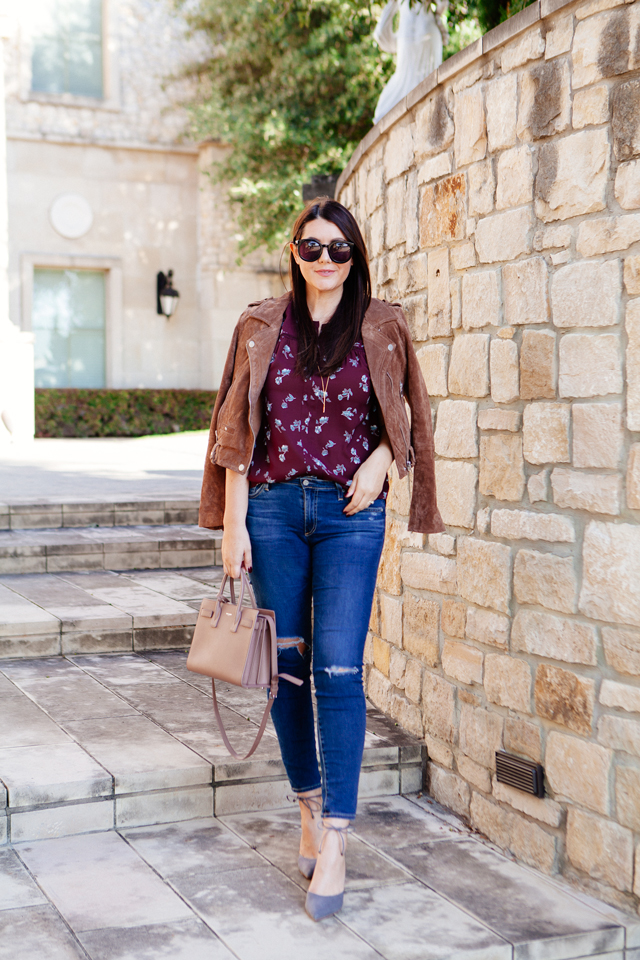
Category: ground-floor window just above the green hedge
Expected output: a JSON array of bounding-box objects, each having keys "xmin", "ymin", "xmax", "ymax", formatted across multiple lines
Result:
[{"xmin": 32, "ymin": 269, "xmax": 105, "ymax": 387}]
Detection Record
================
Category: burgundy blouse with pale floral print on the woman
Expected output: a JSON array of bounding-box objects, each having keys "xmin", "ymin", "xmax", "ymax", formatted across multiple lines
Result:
[{"xmin": 248, "ymin": 303, "xmax": 388, "ymax": 499}]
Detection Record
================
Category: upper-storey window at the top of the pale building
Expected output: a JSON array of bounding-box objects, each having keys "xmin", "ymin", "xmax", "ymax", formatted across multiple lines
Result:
[{"xmin": 31, "ymin": 0, "xmax": 103, "ymax": 98}]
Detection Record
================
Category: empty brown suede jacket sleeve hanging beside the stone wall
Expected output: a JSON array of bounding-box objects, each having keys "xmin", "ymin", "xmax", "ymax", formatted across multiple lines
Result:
[{"xmin": 398, "ymin": 308, "xmax": 445, "ymax": 533}]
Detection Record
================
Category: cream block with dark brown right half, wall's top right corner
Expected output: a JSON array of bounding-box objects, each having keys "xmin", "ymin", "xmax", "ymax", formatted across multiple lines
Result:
[{"xmin": 572, "ymin": 10, "xmax": 631, "ymax": 90}]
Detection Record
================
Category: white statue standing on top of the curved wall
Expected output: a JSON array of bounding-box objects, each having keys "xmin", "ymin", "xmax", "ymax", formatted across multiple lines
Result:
[{"xmin": 373, "ymin": 0, "xmax": 448, "ymax": 123}]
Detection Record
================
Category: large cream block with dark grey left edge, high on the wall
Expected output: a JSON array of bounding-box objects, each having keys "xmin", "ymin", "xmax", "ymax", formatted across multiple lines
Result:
[{"xmin": 535, "ymin": 130, "xmax": 610, "ymax": 222}]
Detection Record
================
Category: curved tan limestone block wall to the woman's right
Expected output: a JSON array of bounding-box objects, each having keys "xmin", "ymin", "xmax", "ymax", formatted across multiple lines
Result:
[{"xmin": 337, "ymin": 0, "xmax": 640, "ymax": 910}]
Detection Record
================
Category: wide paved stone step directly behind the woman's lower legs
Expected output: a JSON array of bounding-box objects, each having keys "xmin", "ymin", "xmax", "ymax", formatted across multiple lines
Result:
[{"xmin": 0, "ymin": 651, "xmax": 426, "ymax": 843}]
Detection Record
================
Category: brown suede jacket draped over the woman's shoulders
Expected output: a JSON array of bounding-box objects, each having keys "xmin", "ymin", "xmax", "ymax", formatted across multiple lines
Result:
[{"xmin": 199, "ymin": 293, "xmax": 444, "ymax": 533}]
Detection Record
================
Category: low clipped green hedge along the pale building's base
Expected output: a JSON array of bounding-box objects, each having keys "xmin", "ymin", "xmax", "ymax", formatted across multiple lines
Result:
[{"xmin": 36, "ymin": 389, "xmax": 216, "ymax": 437}]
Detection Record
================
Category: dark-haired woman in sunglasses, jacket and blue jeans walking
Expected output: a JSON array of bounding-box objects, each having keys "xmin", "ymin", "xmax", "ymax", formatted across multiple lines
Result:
[{"xmin": 200, "ymin": 197, "xmax": 444, "ymax": 920}]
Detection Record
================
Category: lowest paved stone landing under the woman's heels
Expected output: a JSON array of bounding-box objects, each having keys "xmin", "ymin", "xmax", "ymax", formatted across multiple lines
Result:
[{"xmin": 0, "ymin": 796, "xmax": 640, "ymax": 960}]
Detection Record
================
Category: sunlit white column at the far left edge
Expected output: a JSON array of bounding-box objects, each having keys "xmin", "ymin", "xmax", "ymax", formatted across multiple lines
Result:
[{"xmin": 0, "ymin": 9, "xmax": 35, "ymax": 441}]
